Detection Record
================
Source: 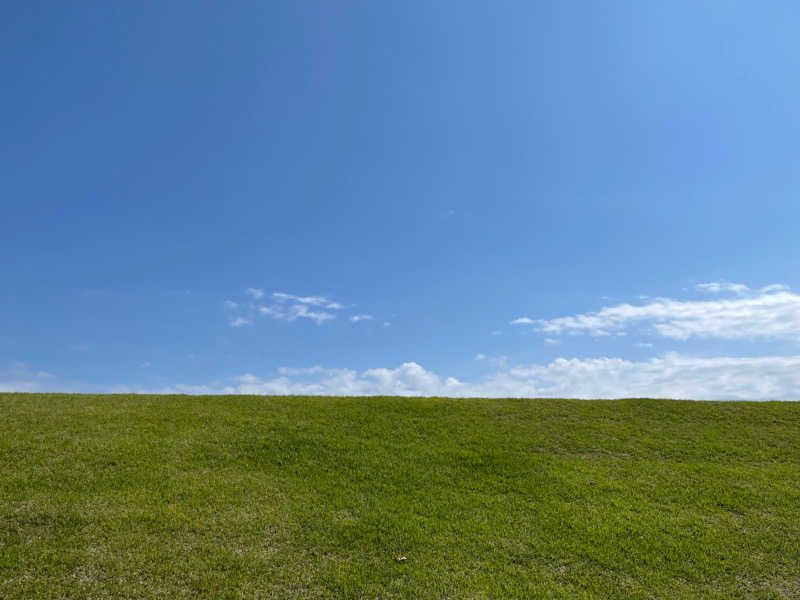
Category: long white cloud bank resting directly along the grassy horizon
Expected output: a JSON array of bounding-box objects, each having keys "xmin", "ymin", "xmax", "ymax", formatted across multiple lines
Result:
[{"xmin": 138, "ymin": 354, "xmax": 800, "ymax": 400}]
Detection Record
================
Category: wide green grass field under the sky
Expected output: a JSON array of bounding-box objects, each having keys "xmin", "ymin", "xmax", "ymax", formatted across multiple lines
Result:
[{"xmin": 0, "ymin": 394, "xmax": 800, "ymax": 600}]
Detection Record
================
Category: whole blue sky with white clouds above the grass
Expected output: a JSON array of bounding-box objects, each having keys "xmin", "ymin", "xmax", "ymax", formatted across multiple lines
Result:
[{"xmin": 0, "ymin": 0, "xmax": 800, "ymax": 400}]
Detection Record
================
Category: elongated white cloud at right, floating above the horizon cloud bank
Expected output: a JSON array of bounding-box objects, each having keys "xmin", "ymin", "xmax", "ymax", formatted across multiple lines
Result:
[{"xmin": 535, "ymin": 286, "xmax": 800, "ymax": 340}]
